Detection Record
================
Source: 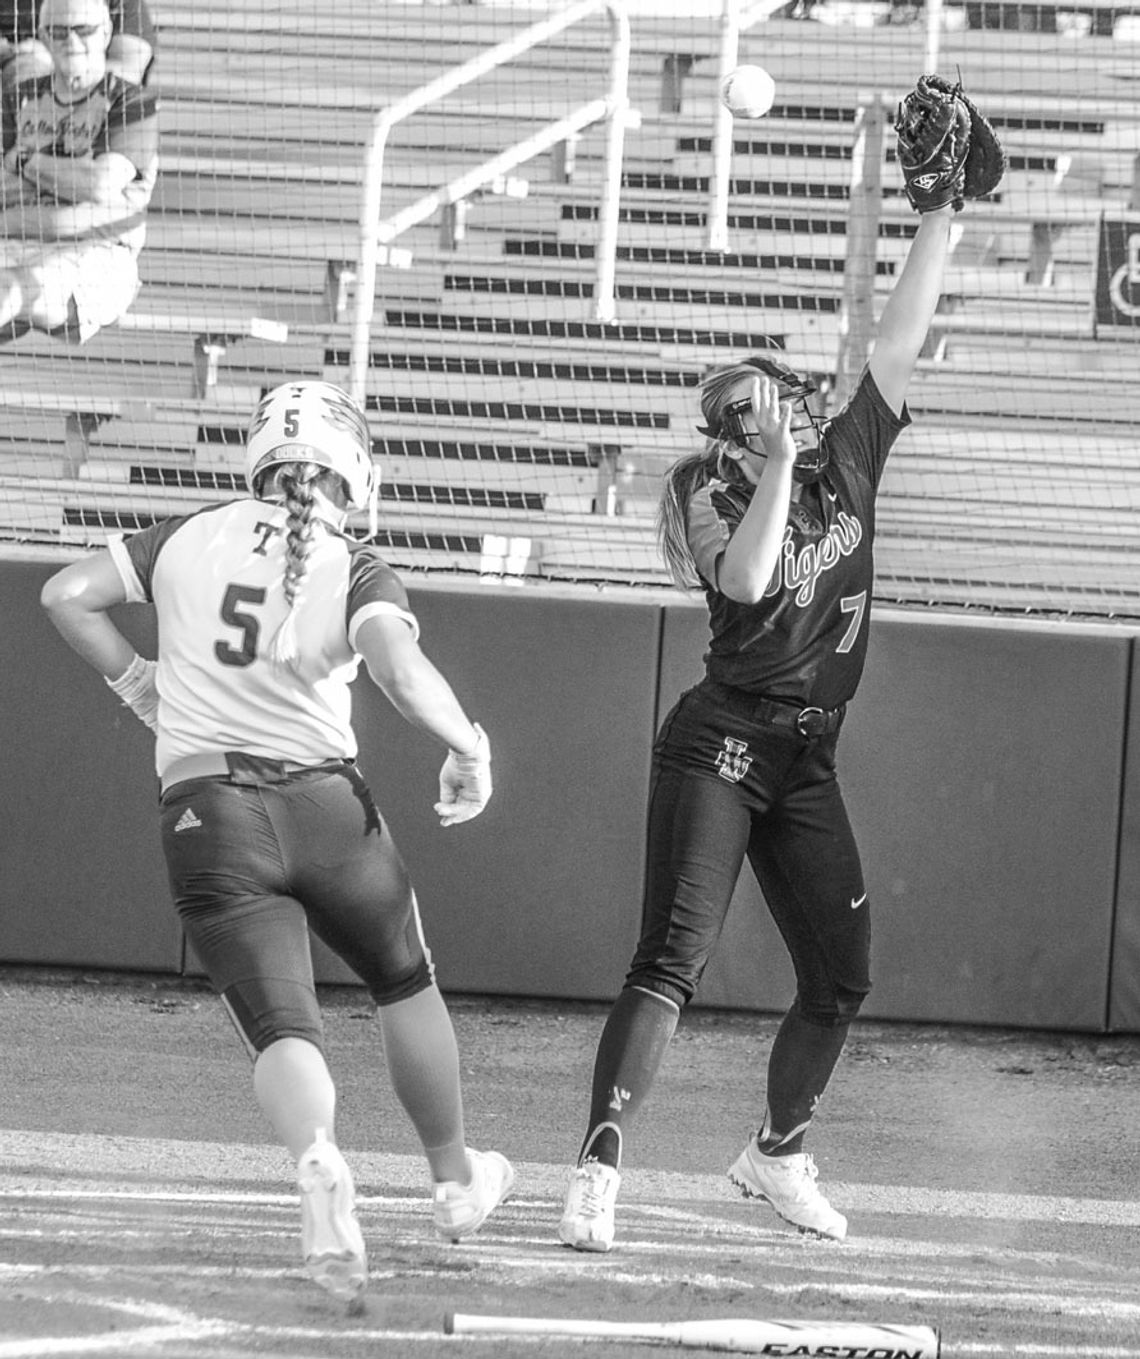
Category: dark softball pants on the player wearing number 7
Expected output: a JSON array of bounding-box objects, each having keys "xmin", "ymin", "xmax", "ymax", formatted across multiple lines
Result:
[{"xmin": 626, "ymin": 682, "xmax": 871, "ymax": 1026}]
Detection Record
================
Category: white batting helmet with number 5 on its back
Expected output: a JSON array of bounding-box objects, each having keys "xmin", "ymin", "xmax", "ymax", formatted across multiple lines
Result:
[{"xmin": 246, "ymin": 381, "xmax": 376, "ymax": 510}]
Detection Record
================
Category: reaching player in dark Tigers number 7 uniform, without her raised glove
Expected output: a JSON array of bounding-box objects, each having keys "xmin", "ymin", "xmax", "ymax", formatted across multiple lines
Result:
[{"xmin": 558, "ymin": 207, "xmax": 951, "ymax": 1250}]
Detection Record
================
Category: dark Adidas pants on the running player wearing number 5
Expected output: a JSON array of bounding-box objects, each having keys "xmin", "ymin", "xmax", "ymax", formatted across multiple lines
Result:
[{"xmin": 162, "ymin": 764, "xmax": 432, "ymax": 1052}]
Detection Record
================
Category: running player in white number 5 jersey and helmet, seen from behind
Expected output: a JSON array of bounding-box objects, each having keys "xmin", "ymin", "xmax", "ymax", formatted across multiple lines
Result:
[{"xmin": 43, "ymin": 382, "xmax": 514, "ymax": 1302}]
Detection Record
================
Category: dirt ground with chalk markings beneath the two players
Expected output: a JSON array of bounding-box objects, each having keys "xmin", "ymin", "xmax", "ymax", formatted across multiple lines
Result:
[{"xmin": 0, "ymin": 969, "xmax": 1140, "ymax": 1359}]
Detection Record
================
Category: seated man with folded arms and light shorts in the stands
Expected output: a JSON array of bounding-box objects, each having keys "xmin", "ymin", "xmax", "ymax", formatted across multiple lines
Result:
[{"xmin": 0, "ymin": 0, "xmax": 158, "ymax": 344}]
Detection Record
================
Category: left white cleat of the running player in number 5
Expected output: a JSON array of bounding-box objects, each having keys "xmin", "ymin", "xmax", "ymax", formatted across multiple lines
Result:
[{"xmin": 298, "ymin": 1133, "xmax": 368, "ymax": 1302}]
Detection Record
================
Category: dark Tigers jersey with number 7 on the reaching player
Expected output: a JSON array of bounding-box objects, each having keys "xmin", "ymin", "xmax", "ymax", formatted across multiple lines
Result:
[{"xmin": 688, "ymin": 371, "xmax": 910, "ymax": 708}]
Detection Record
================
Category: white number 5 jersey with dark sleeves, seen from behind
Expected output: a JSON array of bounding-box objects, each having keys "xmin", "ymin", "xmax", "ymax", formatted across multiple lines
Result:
[{"xmin": 109, "ymin": 499, "xmax": 418, "ymax": 777}]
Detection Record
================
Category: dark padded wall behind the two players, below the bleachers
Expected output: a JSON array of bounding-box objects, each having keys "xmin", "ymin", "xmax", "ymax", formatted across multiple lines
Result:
[{"xmin": 0, "ymin": 561, "xmax": 1140, "ymax": 1031}]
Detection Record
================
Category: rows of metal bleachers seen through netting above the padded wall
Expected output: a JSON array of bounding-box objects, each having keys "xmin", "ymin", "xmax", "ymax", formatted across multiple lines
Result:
[{"xmin": 0, "ymin": 0, "xmax": 1140, "ymax": 616}]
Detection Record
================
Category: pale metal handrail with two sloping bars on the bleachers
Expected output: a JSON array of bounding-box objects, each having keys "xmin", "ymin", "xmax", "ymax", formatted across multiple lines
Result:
[{"xmin": 348, "ymin": 0, "xmax": 630, "ymax": 404}]
